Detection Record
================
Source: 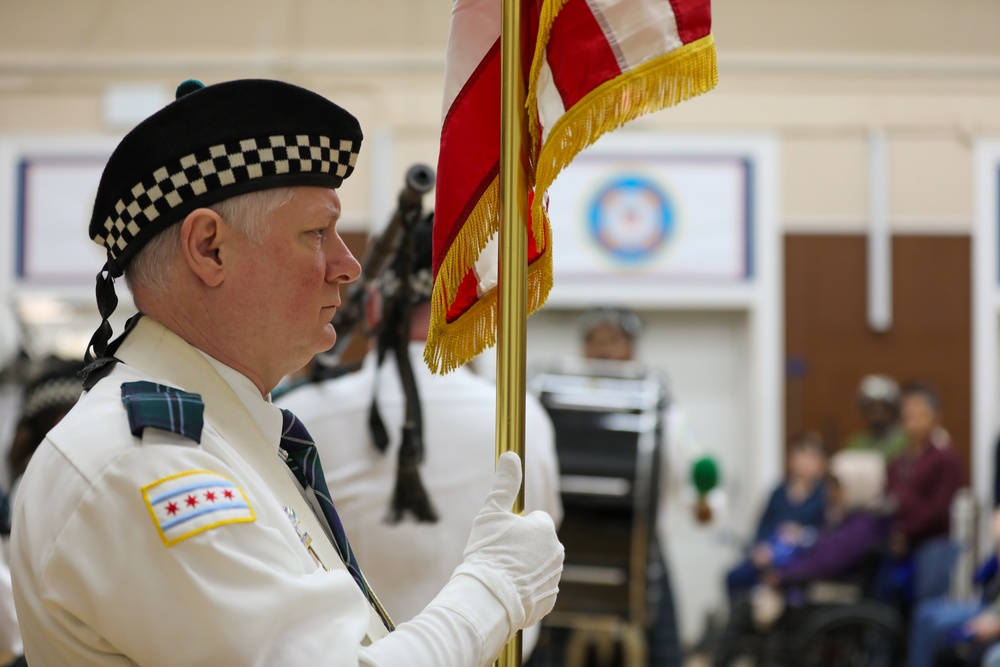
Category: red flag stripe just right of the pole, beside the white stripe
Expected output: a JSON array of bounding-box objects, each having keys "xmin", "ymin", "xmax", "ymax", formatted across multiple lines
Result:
[{"xmin": 546, "ymin": 0, "xmax": 621, "ymax": 109}]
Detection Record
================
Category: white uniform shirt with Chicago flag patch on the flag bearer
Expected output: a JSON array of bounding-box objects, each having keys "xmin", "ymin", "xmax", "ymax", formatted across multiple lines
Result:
[{"xmin": 11, "ymin": 317, "xmax": 512, "ymax": 667}]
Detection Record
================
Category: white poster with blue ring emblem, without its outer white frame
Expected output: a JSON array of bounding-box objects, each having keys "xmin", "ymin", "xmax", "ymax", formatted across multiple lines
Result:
[{"xmin": 549, "ymin": 150, "xmax": 753, "ymax": 284}]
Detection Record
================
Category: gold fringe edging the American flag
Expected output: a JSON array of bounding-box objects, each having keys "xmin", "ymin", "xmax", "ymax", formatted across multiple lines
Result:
[{"xmin": 424, "ymin": 32, "xmax": 719, "ymax": 373}]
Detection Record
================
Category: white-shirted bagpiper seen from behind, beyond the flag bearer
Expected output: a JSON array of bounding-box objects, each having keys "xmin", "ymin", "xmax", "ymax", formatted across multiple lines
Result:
[{"xmin": 277, "ymin": 217, "xmax": 562, "ymax": 636}]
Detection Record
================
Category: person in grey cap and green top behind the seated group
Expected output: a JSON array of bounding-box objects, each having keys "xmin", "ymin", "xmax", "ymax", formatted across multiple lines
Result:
[{"xmin": 844, "ymin": 375, "xmax": 907, "ymax": 461}]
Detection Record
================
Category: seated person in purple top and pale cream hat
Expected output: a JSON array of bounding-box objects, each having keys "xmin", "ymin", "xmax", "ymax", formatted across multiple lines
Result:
[{"xmin": 713, "ymin": 451, "xmax": 887, "ymax": 667}]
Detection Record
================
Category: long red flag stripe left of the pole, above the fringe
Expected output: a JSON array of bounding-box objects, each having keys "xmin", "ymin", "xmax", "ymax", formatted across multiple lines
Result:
[{"xmin": 433, "ymin": 39, "xmax": 500, "ymax": 273}]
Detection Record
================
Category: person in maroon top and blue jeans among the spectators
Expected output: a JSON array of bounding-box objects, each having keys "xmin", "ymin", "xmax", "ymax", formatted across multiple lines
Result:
[{"xmin": 880, "ymin": 382, "xmax": 963, "ymax": 610}]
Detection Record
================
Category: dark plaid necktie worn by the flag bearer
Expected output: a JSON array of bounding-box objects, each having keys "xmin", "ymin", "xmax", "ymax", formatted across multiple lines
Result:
[{"xmin": 281, "ymin": 408, "xmax": 392, "ymax": 630}]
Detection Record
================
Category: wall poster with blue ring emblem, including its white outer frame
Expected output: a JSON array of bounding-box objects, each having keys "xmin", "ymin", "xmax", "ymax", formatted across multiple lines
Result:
[{"xmin": 548, "ymin": 131, "xmax": 777, "ymax": 307}]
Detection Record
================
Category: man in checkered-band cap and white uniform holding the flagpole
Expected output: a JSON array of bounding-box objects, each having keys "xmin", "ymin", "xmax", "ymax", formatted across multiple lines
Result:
[{"xmin": 11, "ymin": 80, "xmax": 562, "ymax": 667}]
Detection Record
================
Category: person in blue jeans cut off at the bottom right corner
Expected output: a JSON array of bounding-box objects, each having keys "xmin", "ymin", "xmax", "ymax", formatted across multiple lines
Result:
[{"xmin": 906, "ymin": 509, "xmax": 1000, "ymax": 667}]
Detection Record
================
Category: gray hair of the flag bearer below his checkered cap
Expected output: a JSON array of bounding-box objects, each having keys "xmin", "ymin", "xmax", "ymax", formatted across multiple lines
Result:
[{"xmin": 124, "ymin": 188, "xmax": 295, "ymax": 296}]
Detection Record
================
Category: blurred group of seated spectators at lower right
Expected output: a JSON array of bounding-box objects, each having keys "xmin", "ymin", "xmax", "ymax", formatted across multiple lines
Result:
[{"xmin": 713, "ymin": 375, "xmax": 1000, "ymax": 667}]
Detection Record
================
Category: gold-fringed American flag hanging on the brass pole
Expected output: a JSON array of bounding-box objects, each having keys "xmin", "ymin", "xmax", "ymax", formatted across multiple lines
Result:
[{"xmin": 425, "ymin": 0, "xmax": 718, "ymax": 372}]
